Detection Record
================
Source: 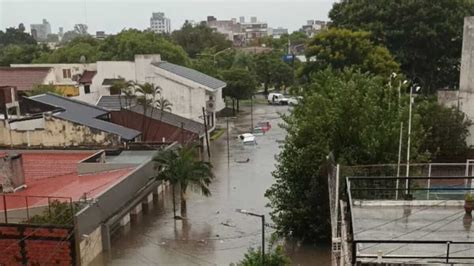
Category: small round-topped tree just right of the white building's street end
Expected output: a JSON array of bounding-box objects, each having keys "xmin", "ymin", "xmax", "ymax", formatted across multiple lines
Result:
[{"xmin": 222, "ymin": 68, "xmax": 257, "ymax": 115}]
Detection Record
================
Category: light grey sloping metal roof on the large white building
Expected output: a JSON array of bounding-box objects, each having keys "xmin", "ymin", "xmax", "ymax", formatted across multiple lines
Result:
[{"xmin": 152, "ymin": 61, "xmax": 227, "ymax": 90}]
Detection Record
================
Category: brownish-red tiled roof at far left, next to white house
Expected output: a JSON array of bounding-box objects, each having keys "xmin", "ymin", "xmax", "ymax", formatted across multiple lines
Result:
[{"xmin": 0, "ymin": 67, "xmax": 51, "ymax": 91}]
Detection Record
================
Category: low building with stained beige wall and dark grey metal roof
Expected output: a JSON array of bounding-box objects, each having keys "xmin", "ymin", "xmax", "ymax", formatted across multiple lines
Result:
[{"xmin": 0, "ymin": 94, "xmax": 141, "ymax": 148}]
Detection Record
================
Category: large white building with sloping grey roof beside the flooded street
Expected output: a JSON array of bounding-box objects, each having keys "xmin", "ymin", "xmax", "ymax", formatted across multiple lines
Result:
[{"xmin": 92, "ymin": 55, "xmax": 226, "ymax": 130}]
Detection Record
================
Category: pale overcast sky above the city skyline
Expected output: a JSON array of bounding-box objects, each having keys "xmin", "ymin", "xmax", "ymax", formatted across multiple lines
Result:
[{"xmin": 0, "ymin": 0, "xmax": 336, "ymax": 33}]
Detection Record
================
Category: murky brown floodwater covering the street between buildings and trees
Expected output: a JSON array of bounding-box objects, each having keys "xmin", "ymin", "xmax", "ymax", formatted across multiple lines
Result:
[{"xmin": 92, "ymin": 105, "xmax": 330, "ymax": 265}]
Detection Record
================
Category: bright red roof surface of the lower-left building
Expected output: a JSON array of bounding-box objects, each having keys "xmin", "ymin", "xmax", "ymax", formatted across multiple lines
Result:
[{"xmin": 0, "ymin": 151, "xmax": 134, "ymax": 210}]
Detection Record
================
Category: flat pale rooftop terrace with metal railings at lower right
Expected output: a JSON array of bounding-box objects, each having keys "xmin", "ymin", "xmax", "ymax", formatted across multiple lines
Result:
[{"xmin": 346, "ymin": 176, "xmax": 474, "ymax": 265}]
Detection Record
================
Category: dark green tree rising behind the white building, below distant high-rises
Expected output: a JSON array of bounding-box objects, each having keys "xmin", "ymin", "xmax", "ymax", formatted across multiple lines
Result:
[{"xmin": 171, "ymin": 22, "xmax": 232, "ymax": 58}]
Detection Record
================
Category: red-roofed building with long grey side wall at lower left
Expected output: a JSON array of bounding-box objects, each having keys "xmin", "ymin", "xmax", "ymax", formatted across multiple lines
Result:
[{"xmin": 0, "ymin": 149, "xmax": 169, "ymax": 265}]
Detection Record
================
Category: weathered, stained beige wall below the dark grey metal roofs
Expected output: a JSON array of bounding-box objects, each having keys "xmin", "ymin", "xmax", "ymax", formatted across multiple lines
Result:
[{"xmin": 0, "ymin": 115, "xmax": 121, "ymax": 147}]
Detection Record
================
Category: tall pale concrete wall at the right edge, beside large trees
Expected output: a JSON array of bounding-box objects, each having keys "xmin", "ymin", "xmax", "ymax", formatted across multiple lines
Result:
[{"xmin": 459, "ymin": 17, "xmax": 474, "ymax": 145}]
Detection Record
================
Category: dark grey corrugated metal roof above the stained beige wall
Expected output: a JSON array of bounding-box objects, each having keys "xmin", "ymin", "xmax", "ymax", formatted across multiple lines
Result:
[{"xmin": 30, "ymin": 93, "xmax": 141, "ymax": 140}]
